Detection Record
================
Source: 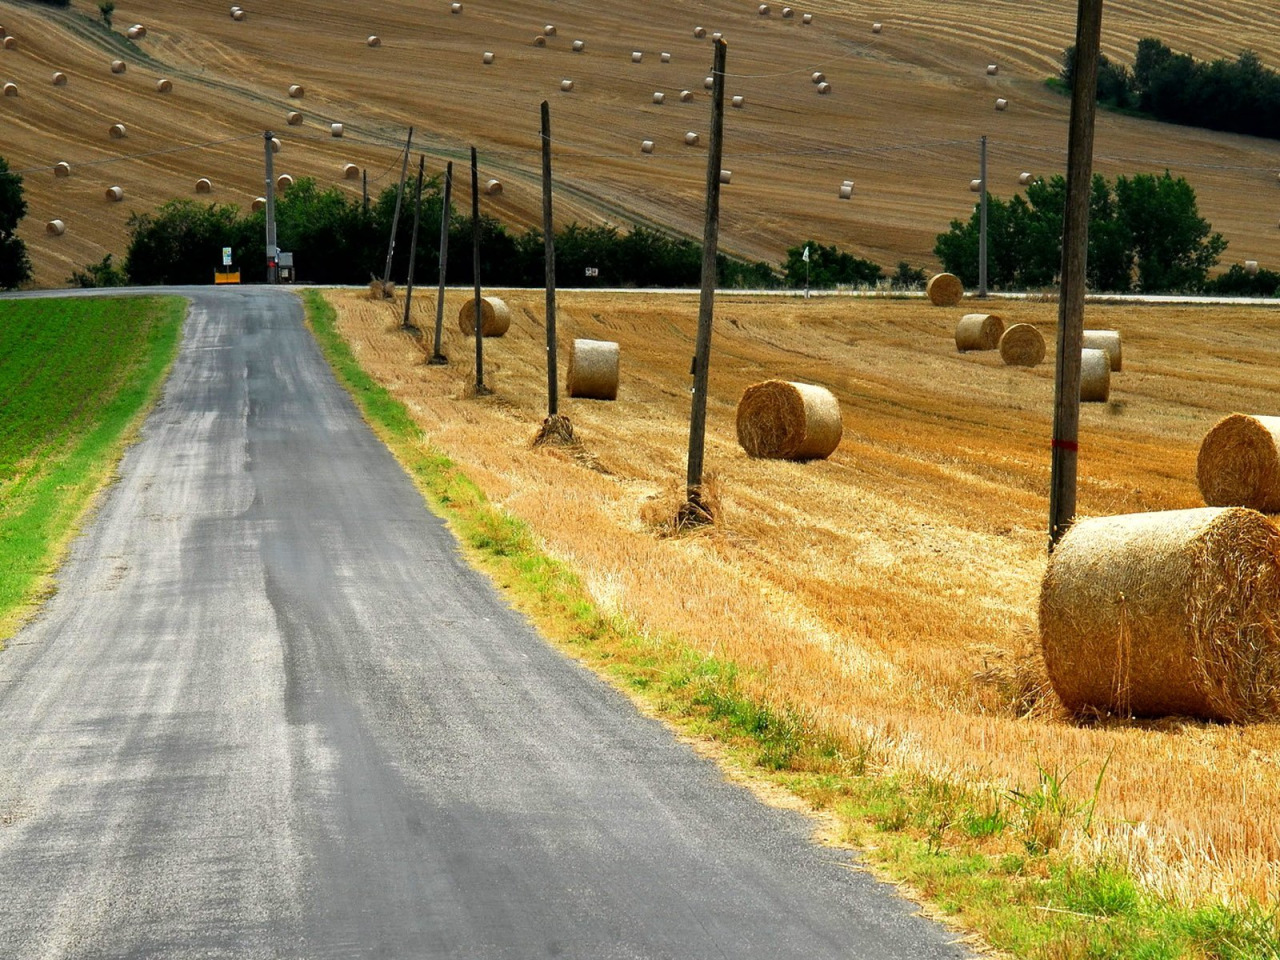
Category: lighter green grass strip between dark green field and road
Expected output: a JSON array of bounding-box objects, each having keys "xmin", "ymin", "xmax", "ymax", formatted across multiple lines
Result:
[{"xmin": 0, "ymin": 297, "xmax": 187, "ymax": 649}]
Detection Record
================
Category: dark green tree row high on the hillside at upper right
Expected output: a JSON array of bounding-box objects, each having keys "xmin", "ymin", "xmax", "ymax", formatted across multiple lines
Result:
[{"xmin": 1060, "ymin": 37, "xmax": 1280, "ymax": 140}]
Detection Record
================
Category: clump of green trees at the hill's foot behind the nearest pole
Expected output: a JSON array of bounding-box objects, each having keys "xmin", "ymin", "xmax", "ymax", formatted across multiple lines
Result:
[{"xmin": 933, "ymin": 170, "xmax": 1226, "ymax": 293}]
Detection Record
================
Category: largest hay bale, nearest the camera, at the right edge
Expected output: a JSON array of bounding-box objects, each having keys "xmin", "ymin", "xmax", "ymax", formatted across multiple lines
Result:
[{"xmin": 1039, "ymin": 507, "xmax": 1280, "ymax": 722}]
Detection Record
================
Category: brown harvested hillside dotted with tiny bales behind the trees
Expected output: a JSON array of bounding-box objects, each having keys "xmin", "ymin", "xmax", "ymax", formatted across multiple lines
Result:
[{"xmin": 0, "ymin": 0, "xmax": 1280, "ymax": 285}]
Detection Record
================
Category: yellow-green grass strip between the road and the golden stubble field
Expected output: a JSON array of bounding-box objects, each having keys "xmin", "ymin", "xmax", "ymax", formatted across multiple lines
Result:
[{"xmin": 303, "ymin": 291, "xmax": 1280, "ymax": 960}]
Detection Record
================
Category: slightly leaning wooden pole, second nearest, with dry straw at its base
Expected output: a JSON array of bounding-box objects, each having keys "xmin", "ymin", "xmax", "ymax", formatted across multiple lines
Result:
[{"xmin": 682, "ymin": 40, "xmax": 728, "ymax": 518}]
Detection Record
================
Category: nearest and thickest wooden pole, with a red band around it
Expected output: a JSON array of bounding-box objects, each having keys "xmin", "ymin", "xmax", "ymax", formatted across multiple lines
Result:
[{"xmin": 1048, "ymin": 0, "xmax": 1102, "ymax": 550}]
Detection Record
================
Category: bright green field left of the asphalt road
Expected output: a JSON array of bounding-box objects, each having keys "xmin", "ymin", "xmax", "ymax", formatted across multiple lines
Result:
[{"xmin": 0, "ymin": 297, "xmax": 186, "ymax": 644}]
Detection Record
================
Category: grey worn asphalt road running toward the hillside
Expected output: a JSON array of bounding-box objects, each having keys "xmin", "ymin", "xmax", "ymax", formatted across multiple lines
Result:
[{"xmin": 0, "ymin": 288, "xmax": 966, "ymax": 960}]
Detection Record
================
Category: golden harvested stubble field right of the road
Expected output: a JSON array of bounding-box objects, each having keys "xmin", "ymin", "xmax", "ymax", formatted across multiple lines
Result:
[{"xmin": 328, "ymin": 291, "xmax": 1280, "ymax": 902}]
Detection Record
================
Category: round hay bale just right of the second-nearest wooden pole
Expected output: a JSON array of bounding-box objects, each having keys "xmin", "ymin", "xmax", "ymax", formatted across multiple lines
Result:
[{"xmin": 737, "ymin": 380, "xmax": 844, "ymax": 460}]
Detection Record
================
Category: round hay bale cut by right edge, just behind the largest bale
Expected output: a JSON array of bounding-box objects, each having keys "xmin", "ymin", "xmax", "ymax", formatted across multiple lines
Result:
[{"xmin": 1196, "ymin": 413, "xmax": 1280, "ymax": 513}]
